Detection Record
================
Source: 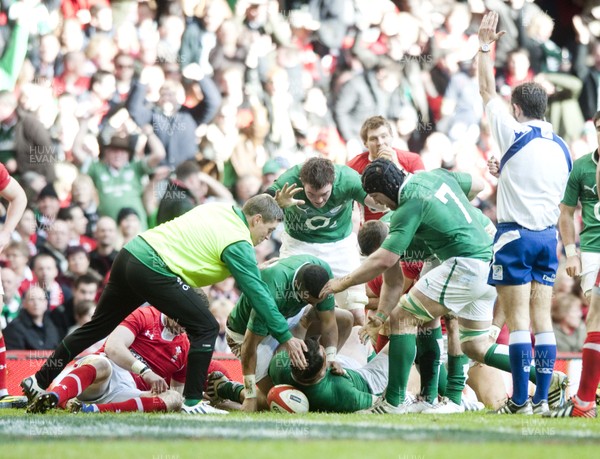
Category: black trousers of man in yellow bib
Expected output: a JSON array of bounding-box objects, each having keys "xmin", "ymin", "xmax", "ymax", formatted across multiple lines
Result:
[{"xmin": 36, "ymin": 249, "xmax": 219, "ymax": 399}]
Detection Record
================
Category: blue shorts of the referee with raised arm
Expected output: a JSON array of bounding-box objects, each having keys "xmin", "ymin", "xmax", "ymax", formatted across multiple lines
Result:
[{"xmin": 488, "ymin": 223, "xmax": 558, "ymax": 285}]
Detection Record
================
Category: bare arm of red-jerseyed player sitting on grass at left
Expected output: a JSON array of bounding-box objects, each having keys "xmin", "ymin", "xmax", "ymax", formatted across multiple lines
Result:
[{"xmin": 104, "ymin": 325, "xmax": 169, "ymax": 394}]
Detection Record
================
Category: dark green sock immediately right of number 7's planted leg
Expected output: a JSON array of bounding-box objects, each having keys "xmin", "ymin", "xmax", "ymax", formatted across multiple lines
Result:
[{"xmin": 417, "ymin": 327, "xmax": 442, "ymax": 402}]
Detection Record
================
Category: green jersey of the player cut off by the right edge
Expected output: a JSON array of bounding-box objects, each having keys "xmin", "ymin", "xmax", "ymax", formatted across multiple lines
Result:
[{"xmin": 562, "ymin": 150, "xmax": 600, "ymax": 253}]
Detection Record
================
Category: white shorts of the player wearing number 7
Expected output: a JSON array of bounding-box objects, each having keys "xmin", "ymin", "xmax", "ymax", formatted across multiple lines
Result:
[{"xmin": 415, "ymin": 257, "xmax": 496, "ymax": 321}]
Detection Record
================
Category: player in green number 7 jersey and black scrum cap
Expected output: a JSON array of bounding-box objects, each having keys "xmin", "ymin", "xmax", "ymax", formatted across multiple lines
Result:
[{"xmin": 322, "ymin": 159, "xmax": 562, "ymax": 414}]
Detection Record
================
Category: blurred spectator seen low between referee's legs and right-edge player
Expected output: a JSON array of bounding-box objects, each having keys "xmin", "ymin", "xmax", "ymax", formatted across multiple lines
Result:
[{"xmin": 552, "ymin": 293, "xmax": 586, "ymax": 352}]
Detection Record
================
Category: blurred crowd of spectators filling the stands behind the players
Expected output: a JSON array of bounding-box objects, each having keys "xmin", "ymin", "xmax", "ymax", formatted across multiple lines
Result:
[{"xmin": 0, "ymin": 0, "xmax": 600, "ymax": 351}]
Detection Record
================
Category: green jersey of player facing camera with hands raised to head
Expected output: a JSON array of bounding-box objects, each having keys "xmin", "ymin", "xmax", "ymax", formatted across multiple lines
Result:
[{"xmin": 269, "ymin": 164, "xmax": 367, "ymax": 243}]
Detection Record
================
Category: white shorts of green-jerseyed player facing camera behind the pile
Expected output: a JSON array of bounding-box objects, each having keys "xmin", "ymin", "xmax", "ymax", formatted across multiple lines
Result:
[{"xmin": 279, "ymin": 232, "xmax": 368, "ymax": 311}]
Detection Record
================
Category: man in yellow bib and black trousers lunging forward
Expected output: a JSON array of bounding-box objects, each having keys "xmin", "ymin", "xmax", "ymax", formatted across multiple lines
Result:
[{"xmin": 21, "ymin": 194, "xmax": 306, "ymax": 414}]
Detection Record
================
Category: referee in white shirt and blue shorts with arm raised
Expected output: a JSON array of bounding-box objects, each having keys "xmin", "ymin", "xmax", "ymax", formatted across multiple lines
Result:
[{"xmin": 478, "ymin": 11, "xmax": 572, "ymax": 414}]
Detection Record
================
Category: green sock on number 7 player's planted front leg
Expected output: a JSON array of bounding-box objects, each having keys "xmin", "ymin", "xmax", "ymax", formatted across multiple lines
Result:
[{"xmin": 385, "ymin": 334, "xmax": 417, "ymax": 406}]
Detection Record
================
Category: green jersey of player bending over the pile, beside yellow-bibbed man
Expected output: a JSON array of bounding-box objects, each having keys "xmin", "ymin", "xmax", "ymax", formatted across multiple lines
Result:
[{"xmin": 227, "ymin": 255, "xmax": 335, "ymax": 336}]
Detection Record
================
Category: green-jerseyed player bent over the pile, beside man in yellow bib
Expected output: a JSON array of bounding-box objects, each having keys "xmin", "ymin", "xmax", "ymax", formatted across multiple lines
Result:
[{"xmin": 226, "ymin": 255, "xmax": 353, "ymax": 411}]
